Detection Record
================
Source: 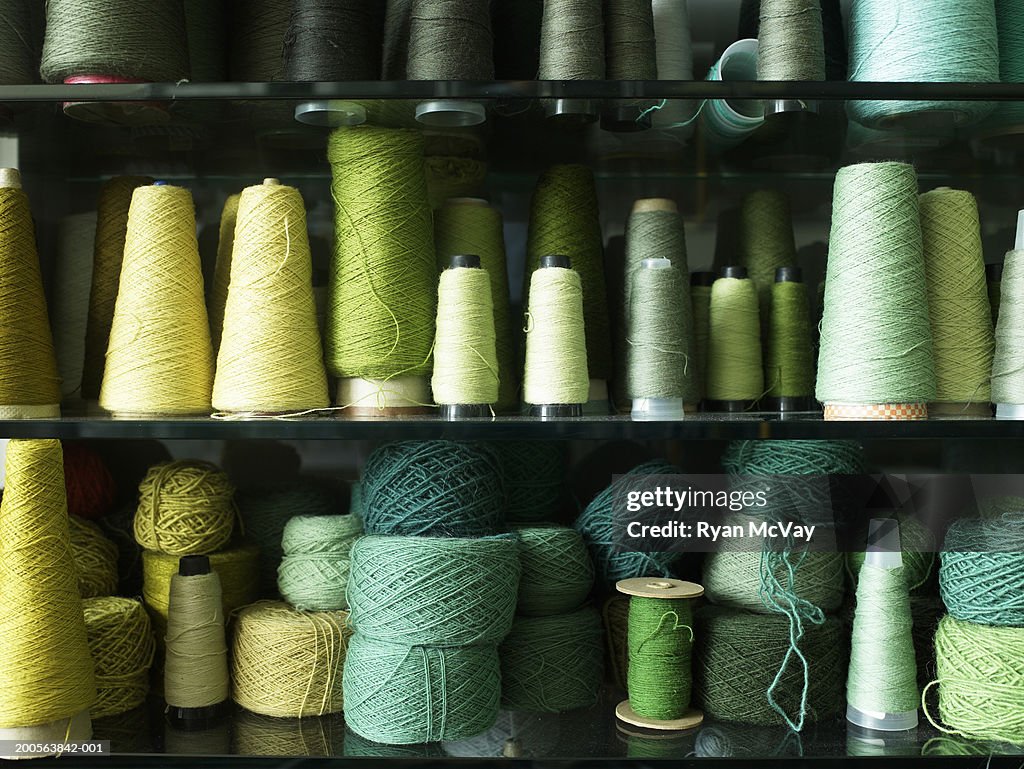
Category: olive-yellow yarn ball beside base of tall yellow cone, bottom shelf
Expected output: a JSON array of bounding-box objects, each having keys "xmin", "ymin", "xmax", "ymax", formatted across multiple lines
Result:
[{"xmin": 82, "ymin": 597, "xmax": 157, "ymax": 718}]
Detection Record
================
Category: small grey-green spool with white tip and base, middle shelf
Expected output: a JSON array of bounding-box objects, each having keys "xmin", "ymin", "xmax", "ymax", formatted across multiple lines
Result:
[{"xmin": 626, "ymin": 259, "xmax": 689, "ymax": 422}]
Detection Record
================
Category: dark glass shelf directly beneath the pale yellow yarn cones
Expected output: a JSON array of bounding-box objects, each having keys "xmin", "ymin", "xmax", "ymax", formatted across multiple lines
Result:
[{"xmin": 0, "ymin": 413, "xmax": 1024, "ymax": 440}]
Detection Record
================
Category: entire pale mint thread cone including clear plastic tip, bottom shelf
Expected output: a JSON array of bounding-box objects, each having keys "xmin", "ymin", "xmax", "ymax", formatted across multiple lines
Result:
[{"xmin": 846, "ymin": 518, "xmax": 921, "ymax": 731}]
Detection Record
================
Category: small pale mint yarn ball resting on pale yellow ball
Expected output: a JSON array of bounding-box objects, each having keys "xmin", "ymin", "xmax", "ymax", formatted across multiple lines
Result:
[{"xmin": 278, "ymin": 515, "xmax": 362, "ymax": 611}]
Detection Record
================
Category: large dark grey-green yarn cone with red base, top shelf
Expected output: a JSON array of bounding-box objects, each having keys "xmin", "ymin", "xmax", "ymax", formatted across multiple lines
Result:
[{"xmin": 40, "ymin": 0, "xmax": 189, "ymax": 126}]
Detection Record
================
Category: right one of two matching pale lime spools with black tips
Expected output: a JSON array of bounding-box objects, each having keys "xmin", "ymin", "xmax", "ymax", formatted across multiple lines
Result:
[{"xmin": 523, "ymin": 255, "xmax": 590, "ymax": 419}]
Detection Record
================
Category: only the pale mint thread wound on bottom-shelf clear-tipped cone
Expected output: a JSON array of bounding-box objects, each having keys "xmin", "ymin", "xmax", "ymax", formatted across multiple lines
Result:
[{"xmin": 846, "ymin": 563, "xmax": 921, "ymax": 715}]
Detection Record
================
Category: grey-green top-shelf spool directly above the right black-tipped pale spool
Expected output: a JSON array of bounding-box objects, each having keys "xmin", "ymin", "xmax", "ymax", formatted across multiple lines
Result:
[{"xmin": 538, "ymin": 0, "xmax": 605, "ymax": 123}]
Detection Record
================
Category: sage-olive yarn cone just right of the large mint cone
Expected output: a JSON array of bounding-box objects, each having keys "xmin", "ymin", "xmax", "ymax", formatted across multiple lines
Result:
[{"xmin": 920, "ymin": 187, "xmax": 995, "ymax": 417}]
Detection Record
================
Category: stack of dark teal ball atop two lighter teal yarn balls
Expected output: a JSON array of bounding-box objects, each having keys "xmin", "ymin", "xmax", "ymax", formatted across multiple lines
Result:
[{"xmin": 344, "ymin": 441, "xmax": 520, "ymax": 744}]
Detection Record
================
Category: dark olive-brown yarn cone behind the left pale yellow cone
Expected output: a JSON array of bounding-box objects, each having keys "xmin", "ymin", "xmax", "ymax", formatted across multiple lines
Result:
[{"xmin": 82, "ymin": 176, "xmax": 153, "ymax": 400}]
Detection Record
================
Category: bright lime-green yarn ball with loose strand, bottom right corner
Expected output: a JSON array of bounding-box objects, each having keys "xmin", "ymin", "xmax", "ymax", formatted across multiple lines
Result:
[{"xmin": 925, "ymin": 615, "xmax": 1024, "ymax": 745}]
